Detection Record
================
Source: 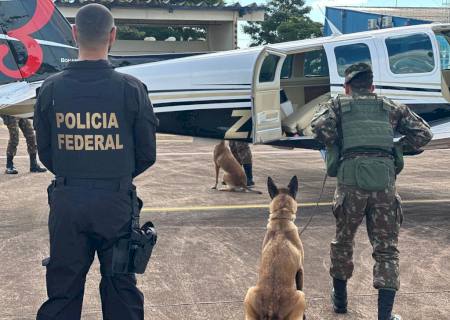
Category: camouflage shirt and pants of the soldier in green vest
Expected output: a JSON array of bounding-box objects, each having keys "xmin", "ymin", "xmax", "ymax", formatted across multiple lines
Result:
[{"xmin": 312, "ymin": 91, "xmax": 432, "ymax": 290}]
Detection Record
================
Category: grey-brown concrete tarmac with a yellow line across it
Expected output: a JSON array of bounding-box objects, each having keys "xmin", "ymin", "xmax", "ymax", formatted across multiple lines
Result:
[{"xmin": 0, "ymin": 127, "xmax": 450, "ymax": 320}]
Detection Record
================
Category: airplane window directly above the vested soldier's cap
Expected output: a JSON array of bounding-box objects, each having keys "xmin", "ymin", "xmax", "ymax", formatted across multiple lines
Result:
[{"xmin": 334, "ymin": 43, "xmax": 372, "ymax": 77}]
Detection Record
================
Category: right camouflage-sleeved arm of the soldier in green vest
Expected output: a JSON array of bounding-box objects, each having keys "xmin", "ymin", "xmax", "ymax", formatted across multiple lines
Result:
[{"xmin": 396, "ymin": 105, "xmax": 433, "ymax": 151}]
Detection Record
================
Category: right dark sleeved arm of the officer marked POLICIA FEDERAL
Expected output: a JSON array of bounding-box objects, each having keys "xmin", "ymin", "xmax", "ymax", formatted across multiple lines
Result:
[{"xmin": 133, "ymin": 83, "xmax": 158, "ymax": 177}]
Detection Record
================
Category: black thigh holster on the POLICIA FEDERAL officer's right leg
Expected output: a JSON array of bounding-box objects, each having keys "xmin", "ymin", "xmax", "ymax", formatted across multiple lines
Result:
[{"xmin": 112, "ymin": 190, "xmax": 157, "ymax": 274}]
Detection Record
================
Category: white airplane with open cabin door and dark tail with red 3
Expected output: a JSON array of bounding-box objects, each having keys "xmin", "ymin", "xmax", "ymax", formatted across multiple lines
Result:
[{"xmin": 0, "ymin": 0, "xmax": 450, "ymax": 149}]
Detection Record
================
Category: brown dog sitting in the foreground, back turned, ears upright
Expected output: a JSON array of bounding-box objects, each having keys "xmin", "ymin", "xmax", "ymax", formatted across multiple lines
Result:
[{"xmin": 244, "ymin": 176, "xmax": 306, "ymax": 320}]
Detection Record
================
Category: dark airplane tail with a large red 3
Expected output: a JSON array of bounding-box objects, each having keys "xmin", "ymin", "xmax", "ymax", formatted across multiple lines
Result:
[{"xmin": 0, "ymin": 0, "xmax": 78, "ymax": 85}]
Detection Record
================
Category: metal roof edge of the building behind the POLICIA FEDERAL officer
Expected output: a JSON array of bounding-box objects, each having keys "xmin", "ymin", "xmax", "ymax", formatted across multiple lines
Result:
[{"xmin": 54, "ymin": 0, "xmax": 266, "ymax": 13}]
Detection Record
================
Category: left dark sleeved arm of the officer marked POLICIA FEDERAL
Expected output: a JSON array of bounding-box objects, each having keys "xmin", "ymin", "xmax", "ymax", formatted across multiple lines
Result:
[{"xmin": 33, "ymin": 83, "xmax": 54, "ymax": 174}]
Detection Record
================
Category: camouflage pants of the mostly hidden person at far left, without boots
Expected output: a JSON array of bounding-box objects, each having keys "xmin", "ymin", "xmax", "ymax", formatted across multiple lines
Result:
[{"xmin": 2, "ymin": 116, "xmax": 37, "ymax": 157}]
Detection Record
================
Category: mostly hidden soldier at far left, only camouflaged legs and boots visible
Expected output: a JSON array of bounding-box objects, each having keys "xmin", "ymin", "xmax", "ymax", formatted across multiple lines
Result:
[{"xmin": 1, "ymin": 116, "xmax": 47, "ymax": 174}]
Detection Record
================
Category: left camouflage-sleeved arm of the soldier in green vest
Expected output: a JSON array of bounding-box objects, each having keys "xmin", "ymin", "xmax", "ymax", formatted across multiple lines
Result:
[{"xmin": 311, "ymin": 99, "xmax": 339, "ymax": 145}]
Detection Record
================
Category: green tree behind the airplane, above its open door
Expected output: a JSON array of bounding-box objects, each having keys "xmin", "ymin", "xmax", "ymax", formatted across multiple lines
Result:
[{"xmin": 244, "ymin": 0, "xmax": 322, "ymax": 46}]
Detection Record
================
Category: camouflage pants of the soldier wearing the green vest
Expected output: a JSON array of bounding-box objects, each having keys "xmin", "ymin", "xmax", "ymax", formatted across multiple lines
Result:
[{"xmin": 330, "ymin": 185, "xmax": 403, "ymax": 290}]
